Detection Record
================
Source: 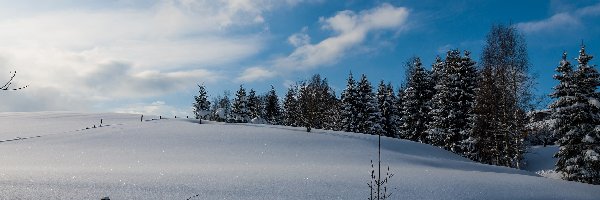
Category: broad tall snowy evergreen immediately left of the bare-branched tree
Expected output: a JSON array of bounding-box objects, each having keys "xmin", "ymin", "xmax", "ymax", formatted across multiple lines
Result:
[{"xmin": 428, "ymin": 50, "xmax": 477, "ymax": 155}]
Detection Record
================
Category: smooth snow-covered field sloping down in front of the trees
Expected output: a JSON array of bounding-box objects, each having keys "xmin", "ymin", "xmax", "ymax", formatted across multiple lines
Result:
[{"xmin": 0, "ymin": 112, "xmax": 600, "ymax": 199}]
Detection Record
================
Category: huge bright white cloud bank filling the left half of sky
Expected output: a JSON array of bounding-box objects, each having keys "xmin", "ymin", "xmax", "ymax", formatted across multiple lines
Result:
[{"xmin": 0, "ymin": 0, "xmax": 308, "ymax": 111}]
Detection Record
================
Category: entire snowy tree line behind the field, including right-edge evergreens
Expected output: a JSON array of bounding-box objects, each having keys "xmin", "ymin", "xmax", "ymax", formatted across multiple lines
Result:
[{"xmin": 194, "ymin": 24, "xmax": 600, "ymax": 184}]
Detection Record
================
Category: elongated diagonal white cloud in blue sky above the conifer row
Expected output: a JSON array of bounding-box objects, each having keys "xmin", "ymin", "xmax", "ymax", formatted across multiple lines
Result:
[{"xmin": 275, "ymin": 4, "xmax": 409, "ymax": 69}]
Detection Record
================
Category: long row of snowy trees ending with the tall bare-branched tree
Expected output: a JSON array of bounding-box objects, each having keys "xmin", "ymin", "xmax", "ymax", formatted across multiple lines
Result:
[{"xmin": 194, "ymin": 25, "xmax": 529, "ymax": 168}]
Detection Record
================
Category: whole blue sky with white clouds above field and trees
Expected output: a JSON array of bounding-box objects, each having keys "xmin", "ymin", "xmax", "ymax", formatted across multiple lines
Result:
[{"xmin": 0, "ymin": 0, "xmax": 600, "ymax": 116}]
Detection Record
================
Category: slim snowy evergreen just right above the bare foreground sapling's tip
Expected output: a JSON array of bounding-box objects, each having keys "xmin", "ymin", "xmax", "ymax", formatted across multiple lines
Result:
[{"xmin": 377, "ymin": 81, "xmax": 398, "ymax": 137}]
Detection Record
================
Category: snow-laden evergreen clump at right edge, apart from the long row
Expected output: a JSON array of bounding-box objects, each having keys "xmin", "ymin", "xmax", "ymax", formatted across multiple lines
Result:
[{"xmin": 552, "ymin": 45, "xmax": 600, "ymax": 184}]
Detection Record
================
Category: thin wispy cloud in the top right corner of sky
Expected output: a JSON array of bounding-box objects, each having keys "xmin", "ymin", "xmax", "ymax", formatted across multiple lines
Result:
[{"xmin": 516, "ymin": 3, "xmax": 600, "ymax": 33}]
